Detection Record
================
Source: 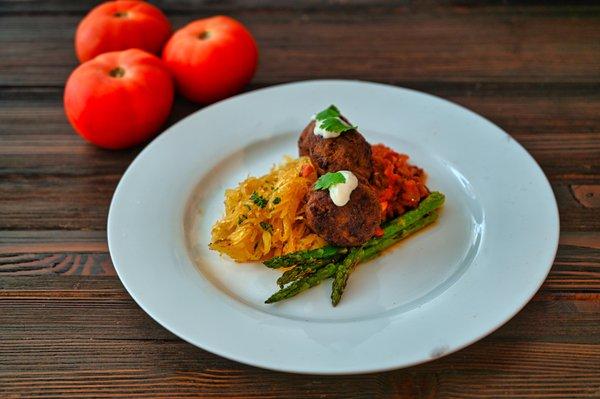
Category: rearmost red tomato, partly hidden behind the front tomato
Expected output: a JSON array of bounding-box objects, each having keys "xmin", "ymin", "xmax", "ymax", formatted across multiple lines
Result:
[{"xmin": 75, "ymin": 0, "xmax": 171, "ymax": 62}]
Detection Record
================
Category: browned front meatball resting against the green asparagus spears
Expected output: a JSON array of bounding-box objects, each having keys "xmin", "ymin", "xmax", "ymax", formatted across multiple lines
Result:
[{"xmin": 306, "ymin": 183, "xmax": 381, "ymax": 246}]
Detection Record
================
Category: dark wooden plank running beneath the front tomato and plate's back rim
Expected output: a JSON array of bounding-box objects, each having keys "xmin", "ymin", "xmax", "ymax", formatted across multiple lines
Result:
[{"xmin": 0, "ymin": 83, "xmax": 600, "ymax": 136}]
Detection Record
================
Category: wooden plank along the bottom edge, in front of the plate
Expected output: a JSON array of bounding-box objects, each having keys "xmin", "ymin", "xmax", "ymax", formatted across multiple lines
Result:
[{"xmin": 0, "ymin": 339, "xmax": 600, "ymax": 398}]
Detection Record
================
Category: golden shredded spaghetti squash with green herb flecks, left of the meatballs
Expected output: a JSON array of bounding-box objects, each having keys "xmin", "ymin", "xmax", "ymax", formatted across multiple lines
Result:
[{"xmin": 209, "ymin": 157, "xmax": 325, "ymax": 262}]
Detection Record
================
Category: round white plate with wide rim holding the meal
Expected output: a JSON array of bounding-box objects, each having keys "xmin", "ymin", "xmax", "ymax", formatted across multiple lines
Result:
[{"xmin": 108, "ymin": 80, "xmax": 559, "ymax": 374}]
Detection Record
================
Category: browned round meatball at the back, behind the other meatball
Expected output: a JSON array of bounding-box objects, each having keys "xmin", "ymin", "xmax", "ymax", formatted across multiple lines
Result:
[{"xmin": 298, "ymin": 121, "xmax": 373, "ymax": 180}]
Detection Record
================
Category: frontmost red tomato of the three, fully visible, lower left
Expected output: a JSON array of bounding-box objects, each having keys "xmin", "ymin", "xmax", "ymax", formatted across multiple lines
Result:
[{"xmin": 64, "ymin": 49, "xmax": 174, "ymax": 149}]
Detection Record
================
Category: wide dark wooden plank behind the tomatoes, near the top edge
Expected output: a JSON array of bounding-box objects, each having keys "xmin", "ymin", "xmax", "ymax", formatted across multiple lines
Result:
[{"xmin": 0, "ymin": 8, "xmax": 600, "ymax": 86}]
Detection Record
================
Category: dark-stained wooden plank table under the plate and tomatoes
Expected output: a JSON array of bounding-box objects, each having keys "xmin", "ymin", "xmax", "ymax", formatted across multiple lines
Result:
[{"xmin": 0, "ymin": 0, "xmax": 600, "ymax": 398}]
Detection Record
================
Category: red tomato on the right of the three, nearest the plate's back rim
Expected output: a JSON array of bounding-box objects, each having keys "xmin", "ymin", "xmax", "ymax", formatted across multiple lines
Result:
[{"xmin": 162, "ymin": 16, "xmax": 258, "ymax": 104}]
